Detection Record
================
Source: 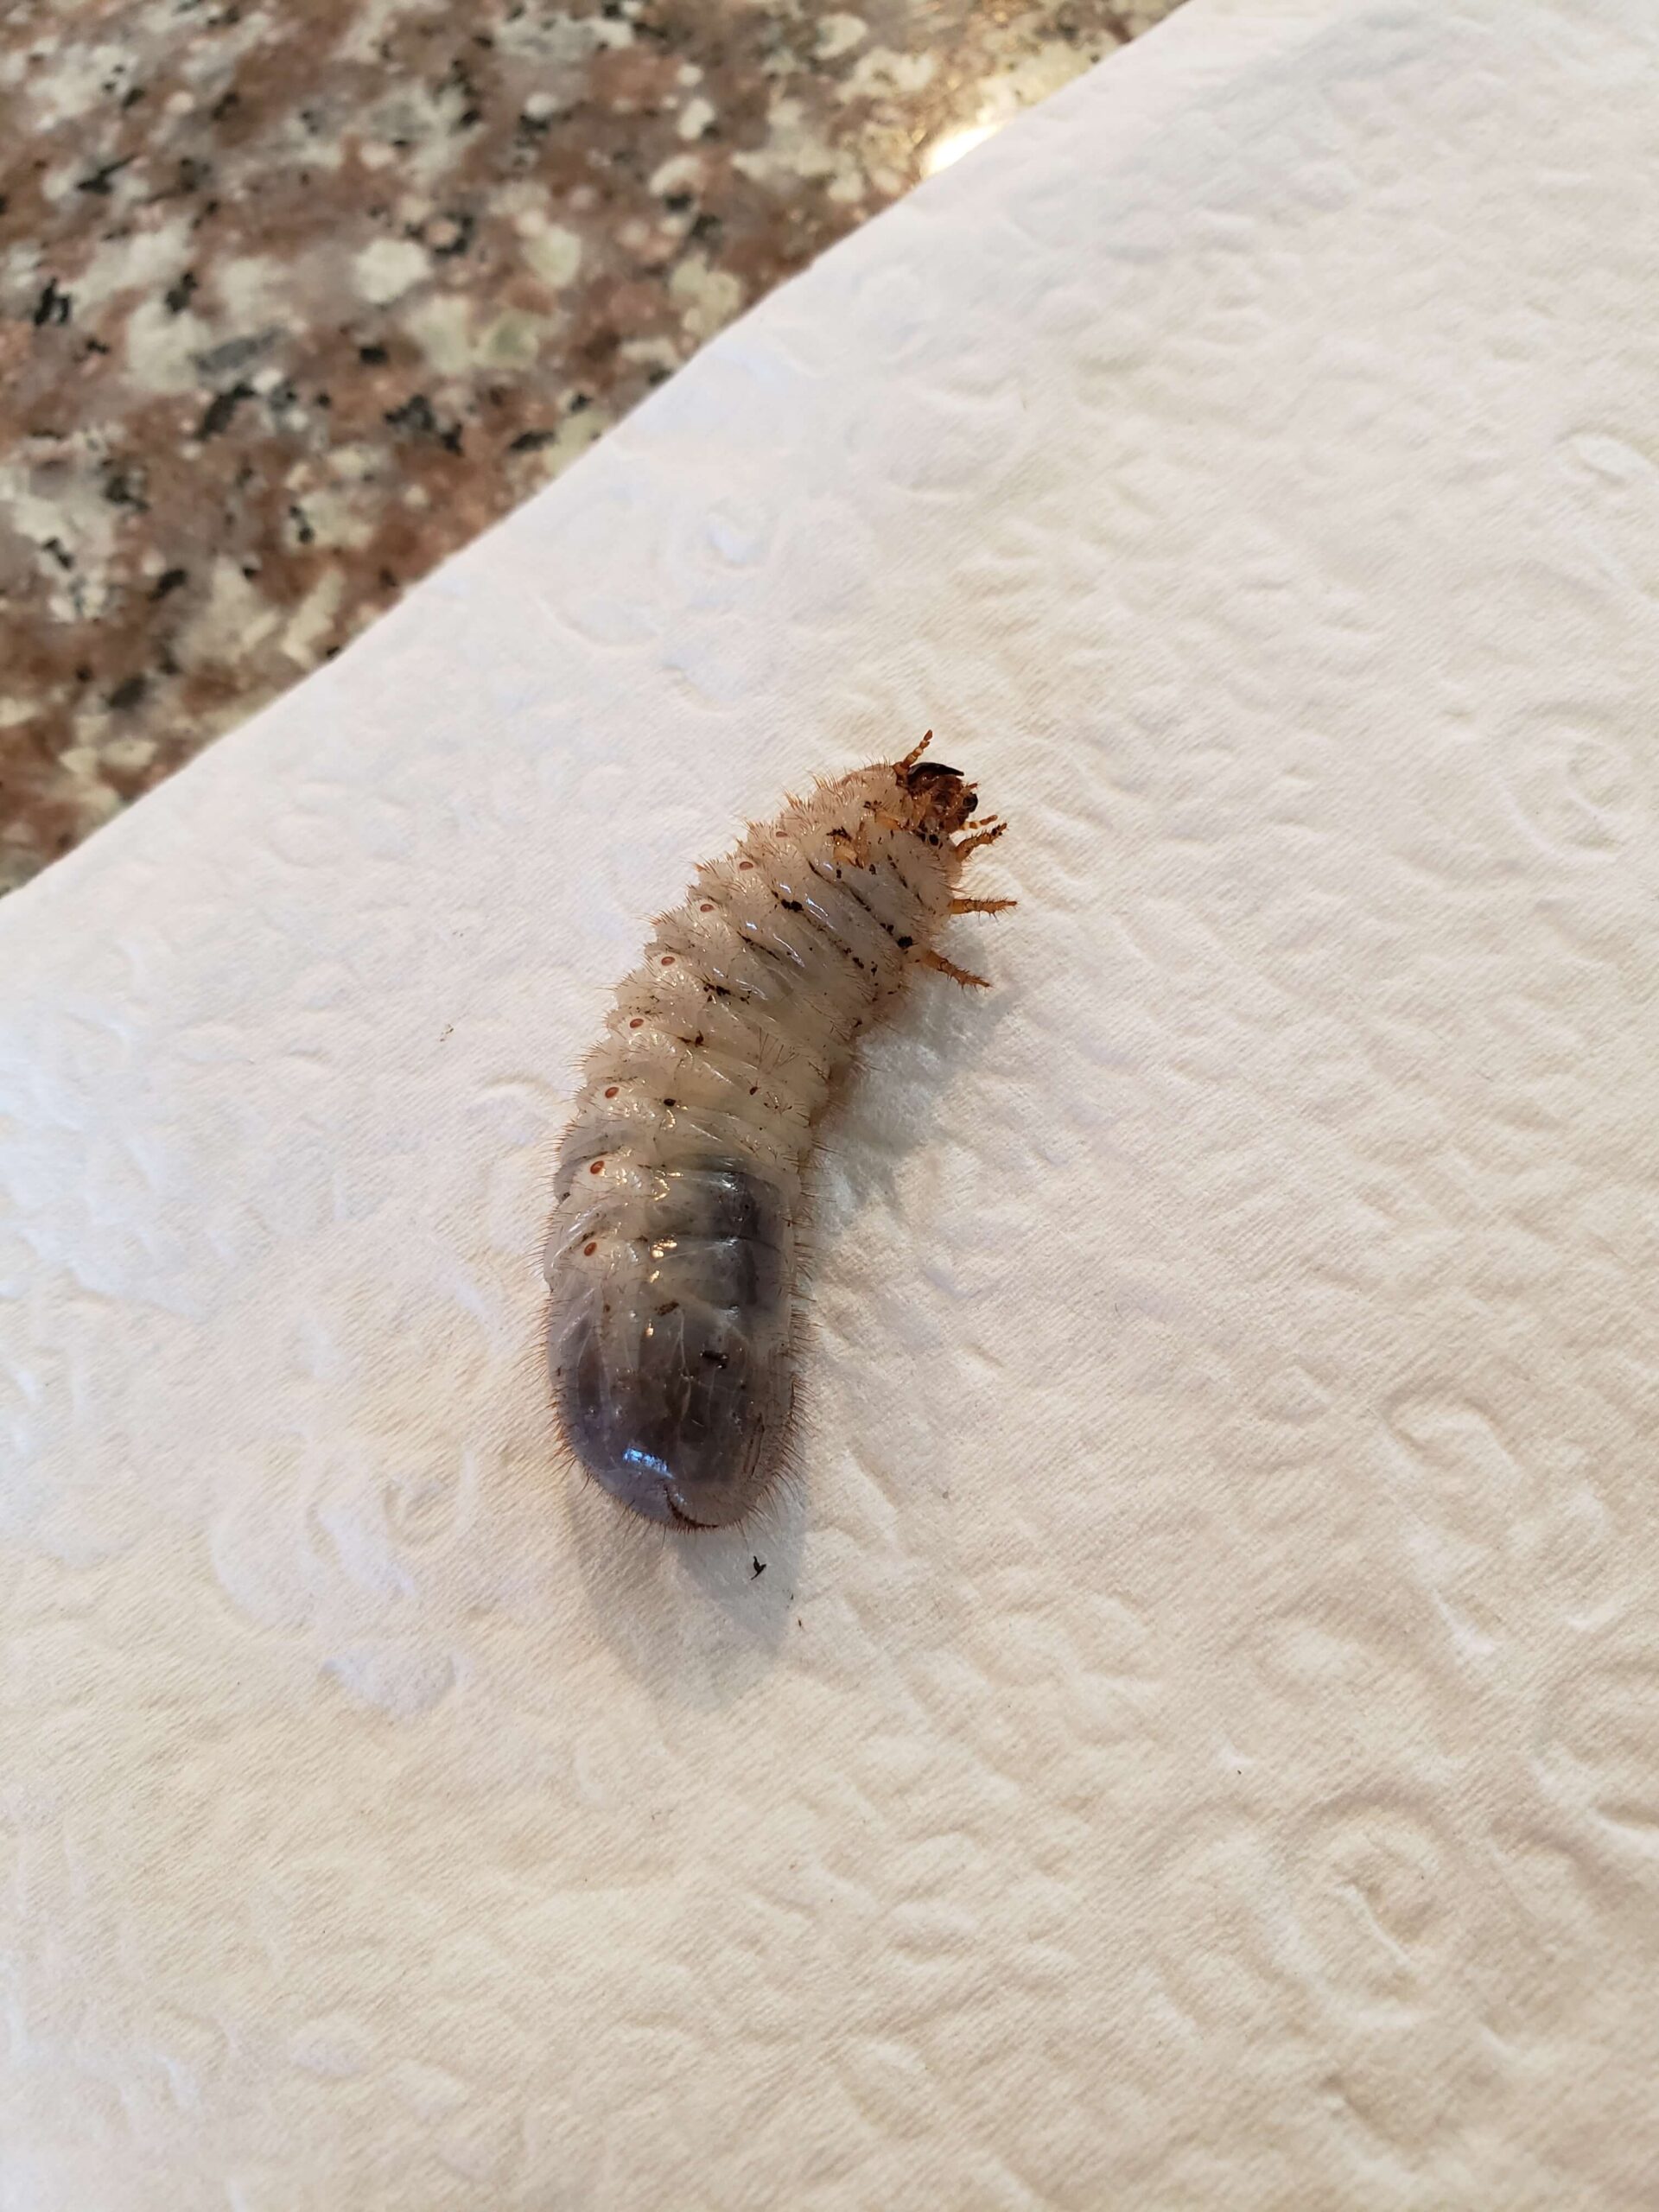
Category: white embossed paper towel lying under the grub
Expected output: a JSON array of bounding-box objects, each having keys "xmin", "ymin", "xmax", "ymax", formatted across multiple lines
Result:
[{"xmin": 0, "ymin": 0, "xmax": 1659, "ymax": 2212}]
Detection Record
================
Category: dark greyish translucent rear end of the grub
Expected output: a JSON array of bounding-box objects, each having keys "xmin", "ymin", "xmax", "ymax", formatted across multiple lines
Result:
[{"xmin": 549, "ymin": 1159, "xmax": 794, "ymax": 1529}]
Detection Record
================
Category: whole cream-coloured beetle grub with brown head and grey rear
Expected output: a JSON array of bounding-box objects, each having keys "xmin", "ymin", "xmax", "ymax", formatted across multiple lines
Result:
[{"xmin": 546, "ymin": 730, "xmax": 1013, "ymax": 1529}]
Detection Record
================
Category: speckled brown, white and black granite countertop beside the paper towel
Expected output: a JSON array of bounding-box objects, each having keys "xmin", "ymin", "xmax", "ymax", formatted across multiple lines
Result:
[{"xmin": 0, "ymin": 0, "xmax": 1177, "ymax": 892}]
